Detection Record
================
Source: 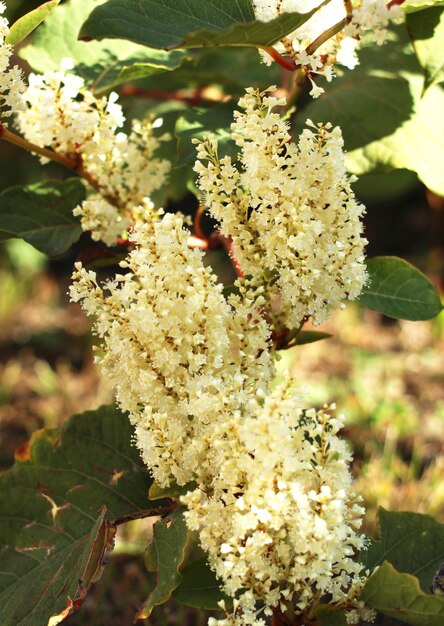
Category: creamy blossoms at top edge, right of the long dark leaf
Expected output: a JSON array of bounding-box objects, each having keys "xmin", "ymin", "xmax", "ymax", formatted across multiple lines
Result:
[{"xmin": 252, "ymin": 0, "xmax": 403, "ymax": 98}]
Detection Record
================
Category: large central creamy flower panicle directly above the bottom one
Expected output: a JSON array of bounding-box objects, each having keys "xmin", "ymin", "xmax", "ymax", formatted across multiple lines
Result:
[{"xmin": 71, "ymin": 214, "xmax": 273, "ymax": 485}]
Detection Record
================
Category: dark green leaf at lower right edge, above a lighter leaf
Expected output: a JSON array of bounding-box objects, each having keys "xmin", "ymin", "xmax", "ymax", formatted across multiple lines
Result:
[{"xmin": 363, "ymin": 508, "xmax": 444, "ymax": 591}]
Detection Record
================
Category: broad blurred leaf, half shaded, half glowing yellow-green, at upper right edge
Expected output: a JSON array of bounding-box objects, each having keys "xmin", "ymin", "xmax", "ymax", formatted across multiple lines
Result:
[{"xmin": 294, "ymin": 27, "xmax": 444, "ymax": 195}]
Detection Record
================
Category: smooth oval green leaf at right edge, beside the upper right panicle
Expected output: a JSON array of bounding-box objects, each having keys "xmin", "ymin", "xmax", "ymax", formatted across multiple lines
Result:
[{"xmin": 359, "ymin": 256, "xmax": 443, "ymax": 321}]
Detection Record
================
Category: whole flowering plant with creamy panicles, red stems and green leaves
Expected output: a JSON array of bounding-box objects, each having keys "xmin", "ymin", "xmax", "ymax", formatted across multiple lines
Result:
[{"xmin": 0, "ymin": 0, "xmax": 444, "ymax": 626}]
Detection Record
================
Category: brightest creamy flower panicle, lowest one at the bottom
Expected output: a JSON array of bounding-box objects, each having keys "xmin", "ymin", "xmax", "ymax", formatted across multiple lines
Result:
[{"xmin": 182, "ymin": 386, "xmax": 365, "ymax": 626}]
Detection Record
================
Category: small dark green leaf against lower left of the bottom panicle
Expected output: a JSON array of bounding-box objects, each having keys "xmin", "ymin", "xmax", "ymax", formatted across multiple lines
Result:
[{"xmin": 172, "ymin": 558, "xmax": 232, "ymax": 610}]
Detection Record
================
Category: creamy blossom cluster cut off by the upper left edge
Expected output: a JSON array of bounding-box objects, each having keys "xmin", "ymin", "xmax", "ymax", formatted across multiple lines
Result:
[{"xmin": 0, "ymin": 2, "xmax": 25, "ymax": 123}]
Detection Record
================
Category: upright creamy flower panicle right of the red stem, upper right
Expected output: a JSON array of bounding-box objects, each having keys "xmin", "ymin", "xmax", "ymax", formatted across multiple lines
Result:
[{"xmin": 195, "ymin": 88, "xmax": 367, "ymax": 328}]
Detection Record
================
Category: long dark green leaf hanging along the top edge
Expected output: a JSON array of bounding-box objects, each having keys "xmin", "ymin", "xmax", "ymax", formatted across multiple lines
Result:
[{"xmin": 80, "ymin": 0, "xmax": 329, "ymax": 50}]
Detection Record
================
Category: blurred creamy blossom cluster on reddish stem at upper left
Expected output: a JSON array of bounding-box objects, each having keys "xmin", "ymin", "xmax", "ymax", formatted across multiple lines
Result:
[{"xmin": 17, "ymin": 59, "xmax": 170, "ymax": 245}]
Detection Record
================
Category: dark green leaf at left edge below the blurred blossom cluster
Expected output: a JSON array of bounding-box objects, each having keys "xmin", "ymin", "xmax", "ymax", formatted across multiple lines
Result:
[{"xmin": 0, "ymin": 178, "xmax": 86, "ymax": 256}]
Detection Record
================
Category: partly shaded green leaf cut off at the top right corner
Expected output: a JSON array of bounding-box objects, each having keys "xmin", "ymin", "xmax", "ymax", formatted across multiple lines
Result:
[{"xmin": 406, "ymin": 5, "xmax": 444, "ymax": 87}]
